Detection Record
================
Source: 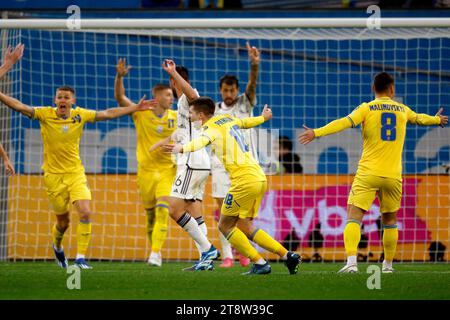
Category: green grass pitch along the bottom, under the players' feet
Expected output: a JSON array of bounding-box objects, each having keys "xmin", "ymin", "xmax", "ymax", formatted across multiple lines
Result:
[{"xmin": 0, "ymin": 261, "xmax": 450, "ymax": 300}]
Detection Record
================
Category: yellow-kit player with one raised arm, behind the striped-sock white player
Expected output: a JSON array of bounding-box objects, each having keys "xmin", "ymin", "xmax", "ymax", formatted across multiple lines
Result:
[{"xmin": 114, "ymin": 59, "xmax": 177, "ymax": 267}]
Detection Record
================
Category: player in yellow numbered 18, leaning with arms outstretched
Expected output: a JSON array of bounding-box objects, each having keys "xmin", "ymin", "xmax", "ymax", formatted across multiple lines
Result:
[{"xmin": 165, "ymin": 97, "xmax": 300, "ymax": 275}]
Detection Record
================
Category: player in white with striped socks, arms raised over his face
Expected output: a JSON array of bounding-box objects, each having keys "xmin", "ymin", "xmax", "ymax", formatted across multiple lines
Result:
[{"xmin": 160, "ymin": 60, "xmax": 220, "ymax": 270}]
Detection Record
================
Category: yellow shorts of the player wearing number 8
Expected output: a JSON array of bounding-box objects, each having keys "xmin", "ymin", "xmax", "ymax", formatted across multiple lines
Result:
[{"xmin": 347, "ymin": 174, "xmax": 402, "ymax": 213}]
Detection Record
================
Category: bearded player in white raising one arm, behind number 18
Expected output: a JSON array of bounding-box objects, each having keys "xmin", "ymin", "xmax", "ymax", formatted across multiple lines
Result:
[{"xmin": 211, "ymin": 42, "xmax": 260, "ymax": 268}]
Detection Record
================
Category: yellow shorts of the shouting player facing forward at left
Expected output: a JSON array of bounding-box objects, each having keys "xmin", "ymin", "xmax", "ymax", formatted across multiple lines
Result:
[{"xmin": 44, "ymin": 172, "xmax": 91, "ymax": 214}]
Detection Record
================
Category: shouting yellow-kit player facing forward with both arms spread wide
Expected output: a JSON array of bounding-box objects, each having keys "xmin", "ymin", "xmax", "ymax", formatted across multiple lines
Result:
[{"xmin": 0, "ymin": 86, "xmax": 154, "ymax": 269}]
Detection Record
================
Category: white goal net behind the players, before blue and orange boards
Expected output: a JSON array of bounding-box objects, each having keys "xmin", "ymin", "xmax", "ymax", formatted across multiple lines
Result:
[{"xmin": 0, "ymin": 19, "xmax": 450, "ymax": 261}]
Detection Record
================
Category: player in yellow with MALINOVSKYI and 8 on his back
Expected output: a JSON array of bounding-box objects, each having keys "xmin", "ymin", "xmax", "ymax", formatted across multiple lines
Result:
[{"xmin": 299, "ymin": 72, "xmax": 448, "ymax": 273}]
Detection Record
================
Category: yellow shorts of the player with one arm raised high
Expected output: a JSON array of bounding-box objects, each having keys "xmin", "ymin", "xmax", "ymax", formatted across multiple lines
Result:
[{"xmin": 137, "ymin": 167, "xmax": 177, "ymax": 209}]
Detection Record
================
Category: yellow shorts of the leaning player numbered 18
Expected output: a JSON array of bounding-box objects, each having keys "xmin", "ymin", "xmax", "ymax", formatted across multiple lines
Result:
[{"xmin": 220, "ymin": 181, "xmax": 267, "ymax": 219}]
